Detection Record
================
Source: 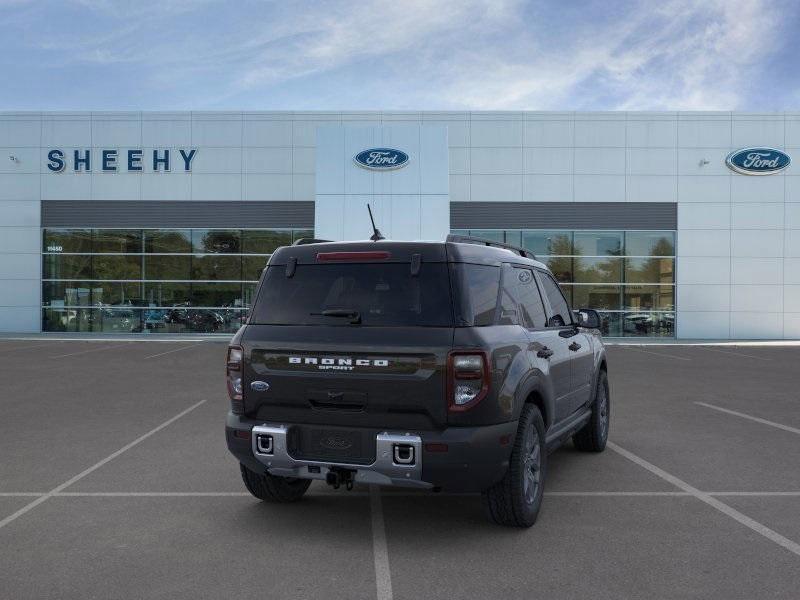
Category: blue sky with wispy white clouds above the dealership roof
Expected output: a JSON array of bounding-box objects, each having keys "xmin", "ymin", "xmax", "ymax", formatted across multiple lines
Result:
[{"xmin": 0, "ymin": 0, "xmax": 800, "ymax": 111}]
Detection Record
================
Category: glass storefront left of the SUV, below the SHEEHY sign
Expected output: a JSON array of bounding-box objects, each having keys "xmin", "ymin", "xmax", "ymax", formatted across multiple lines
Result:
[{"xmin": 42, "ymin": 229, "xmax": 314, "ymax": 333}]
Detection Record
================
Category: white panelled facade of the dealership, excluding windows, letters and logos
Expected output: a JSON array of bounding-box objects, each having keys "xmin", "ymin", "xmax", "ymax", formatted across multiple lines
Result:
[{"xmin": 0, "ymin": 112, "xmax": 800, "ymax": 339}]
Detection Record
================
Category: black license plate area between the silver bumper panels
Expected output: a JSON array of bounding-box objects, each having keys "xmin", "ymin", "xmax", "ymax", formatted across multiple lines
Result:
[{"xmin": 287, "ymin": 425, "xmax": 377, "ymax": 465}]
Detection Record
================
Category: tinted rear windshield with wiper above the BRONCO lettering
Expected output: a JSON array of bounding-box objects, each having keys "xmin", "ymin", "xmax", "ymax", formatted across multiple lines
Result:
[{"xmin": 249, "ymin": 263, "xmax": 453, "ymax": 327}]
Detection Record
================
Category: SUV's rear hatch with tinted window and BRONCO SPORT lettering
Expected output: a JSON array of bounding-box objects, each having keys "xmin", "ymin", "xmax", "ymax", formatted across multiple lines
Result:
[{"xmin": 241, "ymin": 242, "xmax": 453, "ymax": 438}]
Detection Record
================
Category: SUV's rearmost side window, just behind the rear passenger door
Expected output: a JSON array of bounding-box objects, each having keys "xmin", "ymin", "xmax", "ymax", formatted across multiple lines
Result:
[{"xmin": 452, "ymin": 264, "xmax": 500, "ymax": 327}]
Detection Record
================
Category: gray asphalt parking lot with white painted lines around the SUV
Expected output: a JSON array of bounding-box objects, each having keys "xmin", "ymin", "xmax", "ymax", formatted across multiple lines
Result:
[{"xmin": 0, "ymin": 339, "xmax": 800, "ymax": 600}]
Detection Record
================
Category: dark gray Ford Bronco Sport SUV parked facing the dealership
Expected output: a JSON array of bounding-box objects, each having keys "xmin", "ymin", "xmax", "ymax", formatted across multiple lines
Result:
[{"xmin": 226, "ymin": 236, "xmax": 610, "ymax": 527}]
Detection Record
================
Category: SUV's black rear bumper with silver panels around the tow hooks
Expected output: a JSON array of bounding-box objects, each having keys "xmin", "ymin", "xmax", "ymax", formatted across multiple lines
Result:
[{"xmin": 230, "ymin": 413, "xmax": 517, "ymax": 492}]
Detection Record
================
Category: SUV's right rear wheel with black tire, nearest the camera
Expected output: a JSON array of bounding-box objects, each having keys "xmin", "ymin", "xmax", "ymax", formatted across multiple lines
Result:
[{"xmin": 482, "ymin": 404, "xmax": 547, "ymax": 527}]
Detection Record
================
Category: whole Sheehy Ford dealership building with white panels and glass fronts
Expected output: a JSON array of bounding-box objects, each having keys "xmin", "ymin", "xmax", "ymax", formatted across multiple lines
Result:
[{"xmin": 0, "ymin": 112, "xmax": 800, "ymax": 339}]
